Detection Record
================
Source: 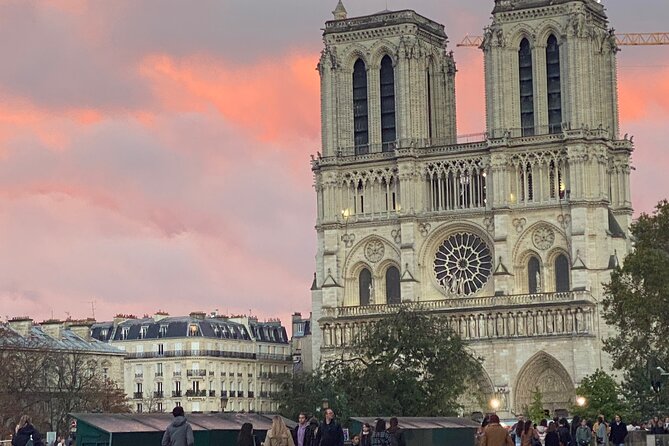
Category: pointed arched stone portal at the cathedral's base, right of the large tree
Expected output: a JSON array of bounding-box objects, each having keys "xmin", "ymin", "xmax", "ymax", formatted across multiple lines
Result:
[{"xmin": 513, "ymin": 351, "xmax": 575, "ymax": 415}]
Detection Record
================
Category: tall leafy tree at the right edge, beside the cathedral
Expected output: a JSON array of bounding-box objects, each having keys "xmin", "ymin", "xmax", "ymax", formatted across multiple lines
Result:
[{"xmin": 603, "ymin": 200, "xmax": 669, "ymax": 415}]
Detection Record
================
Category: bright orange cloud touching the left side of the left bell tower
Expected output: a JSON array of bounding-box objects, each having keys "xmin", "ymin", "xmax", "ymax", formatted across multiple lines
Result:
[{"xmin": 140, "ymin": 54, "xmax": 320, "ymax": 142}]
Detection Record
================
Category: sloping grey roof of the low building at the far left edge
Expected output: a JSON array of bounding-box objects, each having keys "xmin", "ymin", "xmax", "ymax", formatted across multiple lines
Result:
[{"xmin": 0, "ymin": 324, "xmax": 125, "ymax": 355}]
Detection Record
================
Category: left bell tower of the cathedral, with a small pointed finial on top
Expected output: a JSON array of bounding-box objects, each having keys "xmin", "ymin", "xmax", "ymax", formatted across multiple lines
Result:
[{"xmin": 318, "ymin": 1, "xmax": 456, "ymax": 156}]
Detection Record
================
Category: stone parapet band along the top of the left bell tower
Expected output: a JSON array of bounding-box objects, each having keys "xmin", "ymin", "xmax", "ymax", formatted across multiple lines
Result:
[{"xmin": 323, "ymin": 9, "xmax": 446, "ymax": 39}]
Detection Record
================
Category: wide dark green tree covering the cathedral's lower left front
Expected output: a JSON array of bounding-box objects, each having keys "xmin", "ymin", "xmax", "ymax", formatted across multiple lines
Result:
[{"xmin": 278, "ymin": 306, "xmax": 481, "ymax": 419}]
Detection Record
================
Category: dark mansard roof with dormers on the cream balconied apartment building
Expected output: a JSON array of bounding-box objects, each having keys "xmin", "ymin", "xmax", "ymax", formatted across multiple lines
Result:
[{"xmin": 91, "ymin": 316, "xmax": 288, "ymax": 343}]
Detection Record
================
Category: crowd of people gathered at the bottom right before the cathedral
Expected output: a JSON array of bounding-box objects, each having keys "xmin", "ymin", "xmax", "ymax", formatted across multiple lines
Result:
[{"xmin": 477, "ymin": 414, "xmax": 669, "ymax": 446}]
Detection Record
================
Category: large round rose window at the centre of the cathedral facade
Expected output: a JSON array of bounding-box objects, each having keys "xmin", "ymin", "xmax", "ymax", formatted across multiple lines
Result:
[{"xmin": 434, "ymin": 232, "xmax": 493, "ymax": 295}]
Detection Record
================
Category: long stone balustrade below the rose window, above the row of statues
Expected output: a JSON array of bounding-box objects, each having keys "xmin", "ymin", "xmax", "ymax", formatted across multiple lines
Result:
[{"xmin": 322, "ymin": 291, "xmax": 594, "ymax": 319}]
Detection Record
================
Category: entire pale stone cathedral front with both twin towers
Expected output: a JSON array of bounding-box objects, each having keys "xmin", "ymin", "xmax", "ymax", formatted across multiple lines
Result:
[{"xmin": 312, "ymin": 0, "xmax": 633, "ymax": 415}]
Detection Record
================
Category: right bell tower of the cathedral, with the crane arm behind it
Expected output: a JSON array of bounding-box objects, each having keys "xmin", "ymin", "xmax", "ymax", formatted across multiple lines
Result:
[{"xmin": 481, "ymin": 0, "xmax": 618, "ymax": 138}]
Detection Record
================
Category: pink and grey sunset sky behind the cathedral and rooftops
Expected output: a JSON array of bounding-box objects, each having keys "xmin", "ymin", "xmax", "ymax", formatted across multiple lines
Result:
[{"xmin": 0, "ymin": 0, "xmax": 669, "ymax": 323}]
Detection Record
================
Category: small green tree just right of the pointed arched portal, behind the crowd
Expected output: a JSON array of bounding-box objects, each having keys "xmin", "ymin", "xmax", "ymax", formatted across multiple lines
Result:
[{"xmin": 572, "ymin": 369, "xmax": 633, "ymax": 421}]
